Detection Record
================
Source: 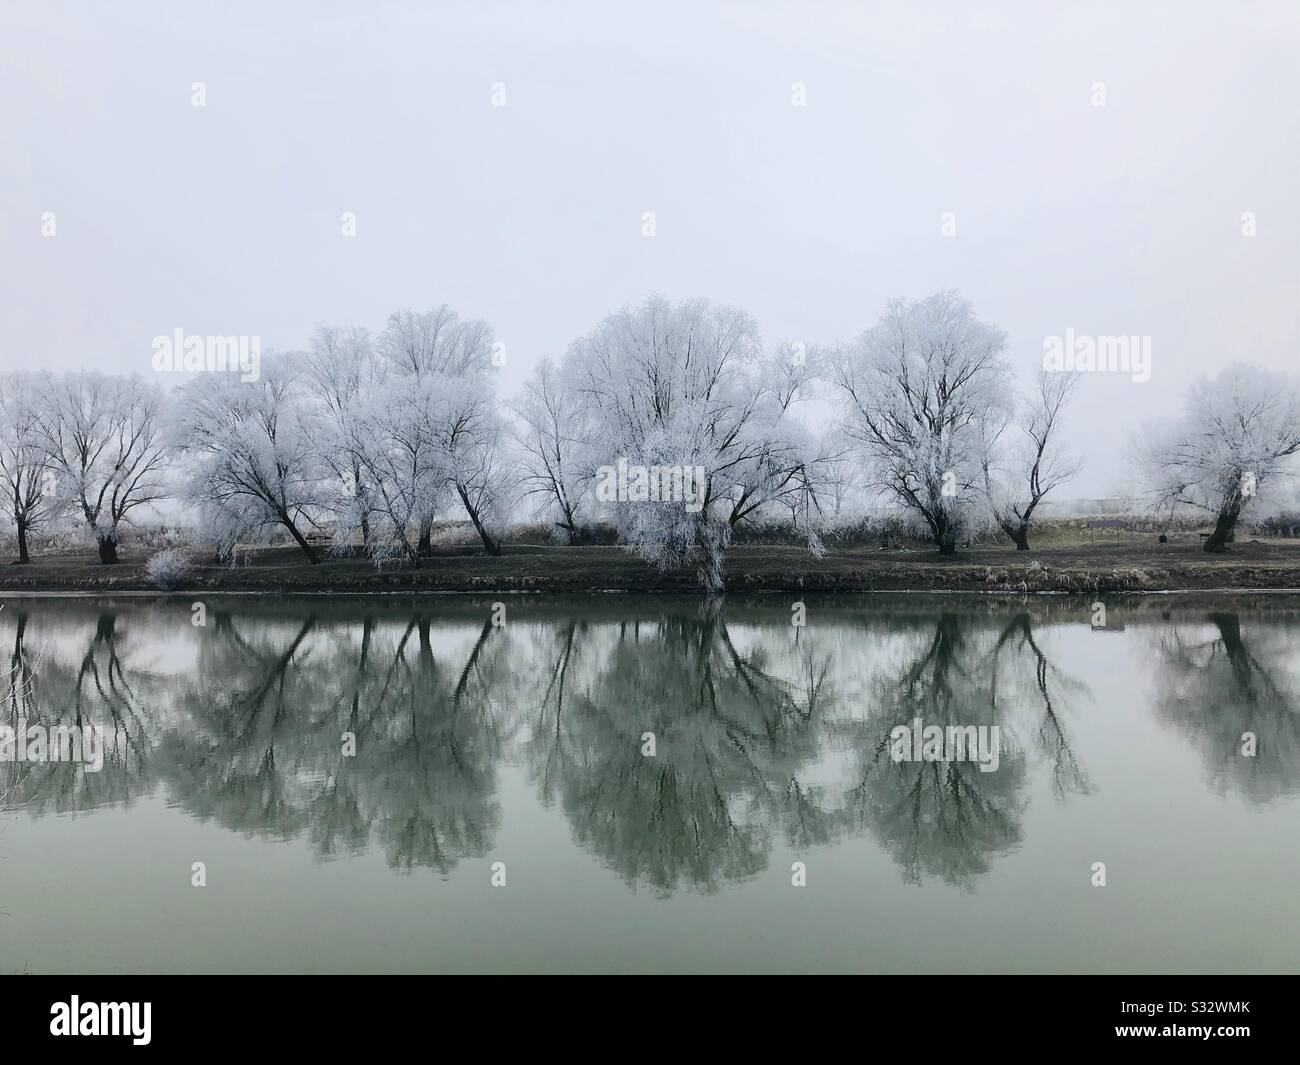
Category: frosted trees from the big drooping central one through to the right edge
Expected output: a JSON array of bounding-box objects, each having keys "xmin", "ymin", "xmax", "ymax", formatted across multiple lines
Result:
[{"xmin": 517, "ymin": 291, "xmax": 1300, "ymax": 569}]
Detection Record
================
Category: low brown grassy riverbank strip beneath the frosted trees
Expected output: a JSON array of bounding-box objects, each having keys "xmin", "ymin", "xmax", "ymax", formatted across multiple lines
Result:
[{"xmin": 0, "ymin": 540, "xmax": 1300, "ymax": 594}]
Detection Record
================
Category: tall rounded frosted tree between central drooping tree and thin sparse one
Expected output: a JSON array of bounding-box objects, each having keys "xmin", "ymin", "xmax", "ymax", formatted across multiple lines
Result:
[{"xmin": 831, "ymin": 291, "xmax": 1008, "ymax": 554}]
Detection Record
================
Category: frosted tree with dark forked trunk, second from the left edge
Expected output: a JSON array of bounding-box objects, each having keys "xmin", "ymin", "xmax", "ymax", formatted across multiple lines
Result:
[{"xmin": 35, "ymin": 372, "xmax": 165, "ymax": 564}]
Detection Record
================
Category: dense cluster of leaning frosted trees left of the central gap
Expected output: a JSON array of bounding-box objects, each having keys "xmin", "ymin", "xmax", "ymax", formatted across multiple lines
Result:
[{"xmin": 183, "ymin": 307, "xmax": 508, "ymax": 564}]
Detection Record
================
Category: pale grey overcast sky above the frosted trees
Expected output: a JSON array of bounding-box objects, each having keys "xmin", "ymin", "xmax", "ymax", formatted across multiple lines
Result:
[{"xmin": 0, "ymin": 0, "xmax": 1300, "ymax": 495}]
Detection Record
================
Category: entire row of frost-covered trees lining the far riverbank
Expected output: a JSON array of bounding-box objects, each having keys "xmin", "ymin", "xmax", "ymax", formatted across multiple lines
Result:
[{"xmin": 0, "ymin": 291, "xmax": 1300, "ymax": 588}]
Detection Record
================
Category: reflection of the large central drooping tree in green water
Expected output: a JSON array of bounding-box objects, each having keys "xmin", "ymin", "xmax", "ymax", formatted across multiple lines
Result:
[{"xmin": 527, "ymin": 603, "xmax": 824, "ymax": 891}]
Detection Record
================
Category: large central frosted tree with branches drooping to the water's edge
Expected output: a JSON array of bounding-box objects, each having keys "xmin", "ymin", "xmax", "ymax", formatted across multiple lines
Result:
[{"xmin": 567, "ymin": 296, "xmax": 801, "ymax": 589}]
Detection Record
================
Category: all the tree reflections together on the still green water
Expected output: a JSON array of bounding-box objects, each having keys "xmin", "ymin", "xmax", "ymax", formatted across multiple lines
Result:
[{"xmin": 0, "ymin": 598, "xmax": 1300, "ymax": 892}]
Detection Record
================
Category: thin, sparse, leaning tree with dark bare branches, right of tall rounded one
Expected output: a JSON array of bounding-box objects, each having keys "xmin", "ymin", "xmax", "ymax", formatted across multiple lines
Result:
[{"xmin": 980, "ymin": 371, "xmax": 1082, "ymax": 551}]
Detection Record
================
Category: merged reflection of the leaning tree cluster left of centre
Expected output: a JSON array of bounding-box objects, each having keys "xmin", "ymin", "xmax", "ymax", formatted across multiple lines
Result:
[{"xmin": 163, "ymin": 614, "xmax": 503, "ymax": 874}]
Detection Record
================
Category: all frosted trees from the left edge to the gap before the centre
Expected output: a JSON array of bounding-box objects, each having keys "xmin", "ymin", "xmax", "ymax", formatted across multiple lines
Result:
[{"xmin": 0, "ymin": 307, "xmax": 506, "ymax": 563}]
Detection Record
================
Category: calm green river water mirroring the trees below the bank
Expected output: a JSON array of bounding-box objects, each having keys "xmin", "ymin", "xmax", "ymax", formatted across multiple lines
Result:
[{"xmin": 0, "ymin": 596, "xmax": 1300, "ymax": 973}]
